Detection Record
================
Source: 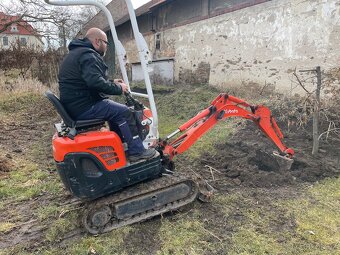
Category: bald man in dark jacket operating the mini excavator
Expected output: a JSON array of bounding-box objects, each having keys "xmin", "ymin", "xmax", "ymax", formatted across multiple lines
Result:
[{"xmin": 58, "ymin": 28, "xmax": 156, "ymax": 161}]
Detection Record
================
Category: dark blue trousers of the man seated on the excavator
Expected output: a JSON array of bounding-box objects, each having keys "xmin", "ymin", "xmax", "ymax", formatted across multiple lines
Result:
[{"xmin": 77, "ymin": 99, "xmax": 144, "ymax": 155}]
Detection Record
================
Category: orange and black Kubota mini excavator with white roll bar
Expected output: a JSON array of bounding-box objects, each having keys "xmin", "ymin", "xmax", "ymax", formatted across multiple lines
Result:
[{"xmin": 45, "ymin": 0, "xmax": 294, "ymax": 234}]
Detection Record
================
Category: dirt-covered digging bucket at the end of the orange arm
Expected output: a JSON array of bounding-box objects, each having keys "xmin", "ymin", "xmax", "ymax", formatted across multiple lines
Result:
[{"xmin": 256, "ymin": 150, "xmax": 294, "ymax": 171}]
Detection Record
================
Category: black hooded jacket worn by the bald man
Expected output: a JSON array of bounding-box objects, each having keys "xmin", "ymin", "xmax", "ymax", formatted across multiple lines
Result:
[{"xmin": 58, "ymin": 38, "xmax": 122, "ymax": 119}]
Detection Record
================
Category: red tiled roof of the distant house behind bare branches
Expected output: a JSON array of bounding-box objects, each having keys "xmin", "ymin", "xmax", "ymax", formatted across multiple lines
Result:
[{"xmin": 0, "ymin": 12, "xmax": 38, "ymax": 36}]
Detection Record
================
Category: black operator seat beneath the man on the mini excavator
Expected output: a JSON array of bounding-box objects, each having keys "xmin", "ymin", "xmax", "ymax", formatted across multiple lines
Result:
[{"xmin": 45, "ymin": 90, "xmax": 105, "ymax": 139}]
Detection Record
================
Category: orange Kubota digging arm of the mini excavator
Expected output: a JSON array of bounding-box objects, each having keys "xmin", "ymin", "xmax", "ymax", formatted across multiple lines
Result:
[{"xmin": 161, "ymin": 93, "xmax": 294, "ymax": 160}]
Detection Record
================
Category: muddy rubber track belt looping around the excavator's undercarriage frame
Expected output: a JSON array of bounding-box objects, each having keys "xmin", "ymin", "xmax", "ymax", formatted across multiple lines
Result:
[{"xmin": 82, "ymin": 175, "xmax": 199, "ymax": 234}]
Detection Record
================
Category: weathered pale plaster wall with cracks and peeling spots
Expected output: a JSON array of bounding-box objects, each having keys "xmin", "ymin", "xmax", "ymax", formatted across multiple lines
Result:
[{"xmin": 126, "ymin": 0, "xmax": 340, "ymax": 92}]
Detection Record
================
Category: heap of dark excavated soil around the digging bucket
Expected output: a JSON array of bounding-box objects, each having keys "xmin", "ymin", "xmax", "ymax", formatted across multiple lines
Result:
[{"xmin": 195, "ymin": 123, "xmax": 340, "ymax": 189}]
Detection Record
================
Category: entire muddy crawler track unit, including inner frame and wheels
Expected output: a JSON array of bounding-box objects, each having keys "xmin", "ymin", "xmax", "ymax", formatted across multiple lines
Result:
[{"xmin": 83, "ymin": 175, "xmax": 199, "ymax": 234}]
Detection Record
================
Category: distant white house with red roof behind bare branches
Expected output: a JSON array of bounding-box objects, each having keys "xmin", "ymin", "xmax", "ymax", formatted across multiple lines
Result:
[{"xmin": 0, "ymin": 12, "xmax": 44, "ymax": 50}]
